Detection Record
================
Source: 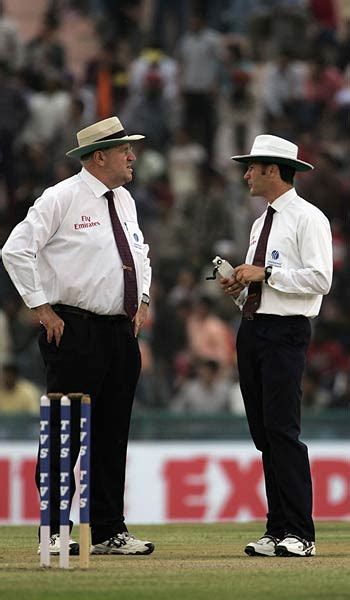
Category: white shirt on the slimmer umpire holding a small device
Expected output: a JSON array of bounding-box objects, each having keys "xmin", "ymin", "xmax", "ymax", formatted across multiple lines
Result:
[{"xmin": 237, "ymin": 188, "xmax": 333, "ymax": 317}]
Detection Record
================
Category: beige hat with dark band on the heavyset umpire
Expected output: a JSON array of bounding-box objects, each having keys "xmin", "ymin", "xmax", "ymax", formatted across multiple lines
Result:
[{"xmin": 66, "ymin": 117, "xmax": 145, "ymax": 158}]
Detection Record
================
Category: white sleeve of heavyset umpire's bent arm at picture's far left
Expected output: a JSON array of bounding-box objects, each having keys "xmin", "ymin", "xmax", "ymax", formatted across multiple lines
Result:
[{"xmin": 2, "ymin": 190, "xmax": 60, "ymax": 308}]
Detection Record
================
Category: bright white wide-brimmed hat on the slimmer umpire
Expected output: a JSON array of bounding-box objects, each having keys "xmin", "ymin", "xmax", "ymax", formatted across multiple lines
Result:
[{"xmin": 231, "ymin": 135, "xmax": 314, "ymax": 171}]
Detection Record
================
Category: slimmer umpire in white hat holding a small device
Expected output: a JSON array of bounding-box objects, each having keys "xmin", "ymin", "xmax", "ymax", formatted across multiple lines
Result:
[{"xmin": 221, "ymin": 135, "xmax": 332, "ymax": 557}]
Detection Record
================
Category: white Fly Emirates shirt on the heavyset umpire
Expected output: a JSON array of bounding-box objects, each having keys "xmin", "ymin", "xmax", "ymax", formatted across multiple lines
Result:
[{"xmin": 2, "ymin": 168, "xmax": 151, "ymax": 315}]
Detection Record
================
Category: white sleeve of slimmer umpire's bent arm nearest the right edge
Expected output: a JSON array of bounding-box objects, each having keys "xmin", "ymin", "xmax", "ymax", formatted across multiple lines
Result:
[{"xmin": 268, "ymin": 213, "xmax": 333, "ymax": 295}]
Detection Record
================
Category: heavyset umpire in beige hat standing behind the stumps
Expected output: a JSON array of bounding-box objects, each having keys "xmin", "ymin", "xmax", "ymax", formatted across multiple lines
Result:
[{"xmin": 2, "ymin": 117, "xmax": 154, "ymax": 554}]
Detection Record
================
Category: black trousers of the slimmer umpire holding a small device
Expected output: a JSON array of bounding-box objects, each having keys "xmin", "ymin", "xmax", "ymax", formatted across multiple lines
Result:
[{"xmin": 237, "ymin": 315, "xmax": 315, "ymax": 540}]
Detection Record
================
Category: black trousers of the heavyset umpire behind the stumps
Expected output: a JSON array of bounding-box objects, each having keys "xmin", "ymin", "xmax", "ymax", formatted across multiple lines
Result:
[{"xmin": 36, "ymin": 309, "xmax": 141, "ymax": 544}]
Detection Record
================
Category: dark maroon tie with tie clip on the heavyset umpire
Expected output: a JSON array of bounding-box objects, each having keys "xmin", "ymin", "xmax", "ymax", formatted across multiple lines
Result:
[{"xmin": 105, "ymin": 190, "xmax": 138, "ymax": 320}]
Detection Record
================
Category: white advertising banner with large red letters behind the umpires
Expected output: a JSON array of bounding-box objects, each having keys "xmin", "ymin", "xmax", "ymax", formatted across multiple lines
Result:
[{"xmin": 0, "ymin": 442, "xmax": 350, "ymax": 524}]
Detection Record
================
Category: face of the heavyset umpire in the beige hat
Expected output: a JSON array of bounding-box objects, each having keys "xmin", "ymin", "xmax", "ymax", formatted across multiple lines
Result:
[{"xmin": 102, "ymin": 143, "xmax": 136, "ymax": 189}]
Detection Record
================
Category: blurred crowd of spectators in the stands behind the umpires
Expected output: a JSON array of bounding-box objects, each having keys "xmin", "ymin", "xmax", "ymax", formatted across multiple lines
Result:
[{"xmin": 0, "ymin": 0, "xmax": 350, "ymax": 414}]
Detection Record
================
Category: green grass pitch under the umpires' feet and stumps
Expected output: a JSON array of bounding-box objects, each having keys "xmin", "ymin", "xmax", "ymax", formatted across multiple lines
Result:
[{"xmin": 0, "ymin": 522, "xmax": 350, "ymax": 600}]
